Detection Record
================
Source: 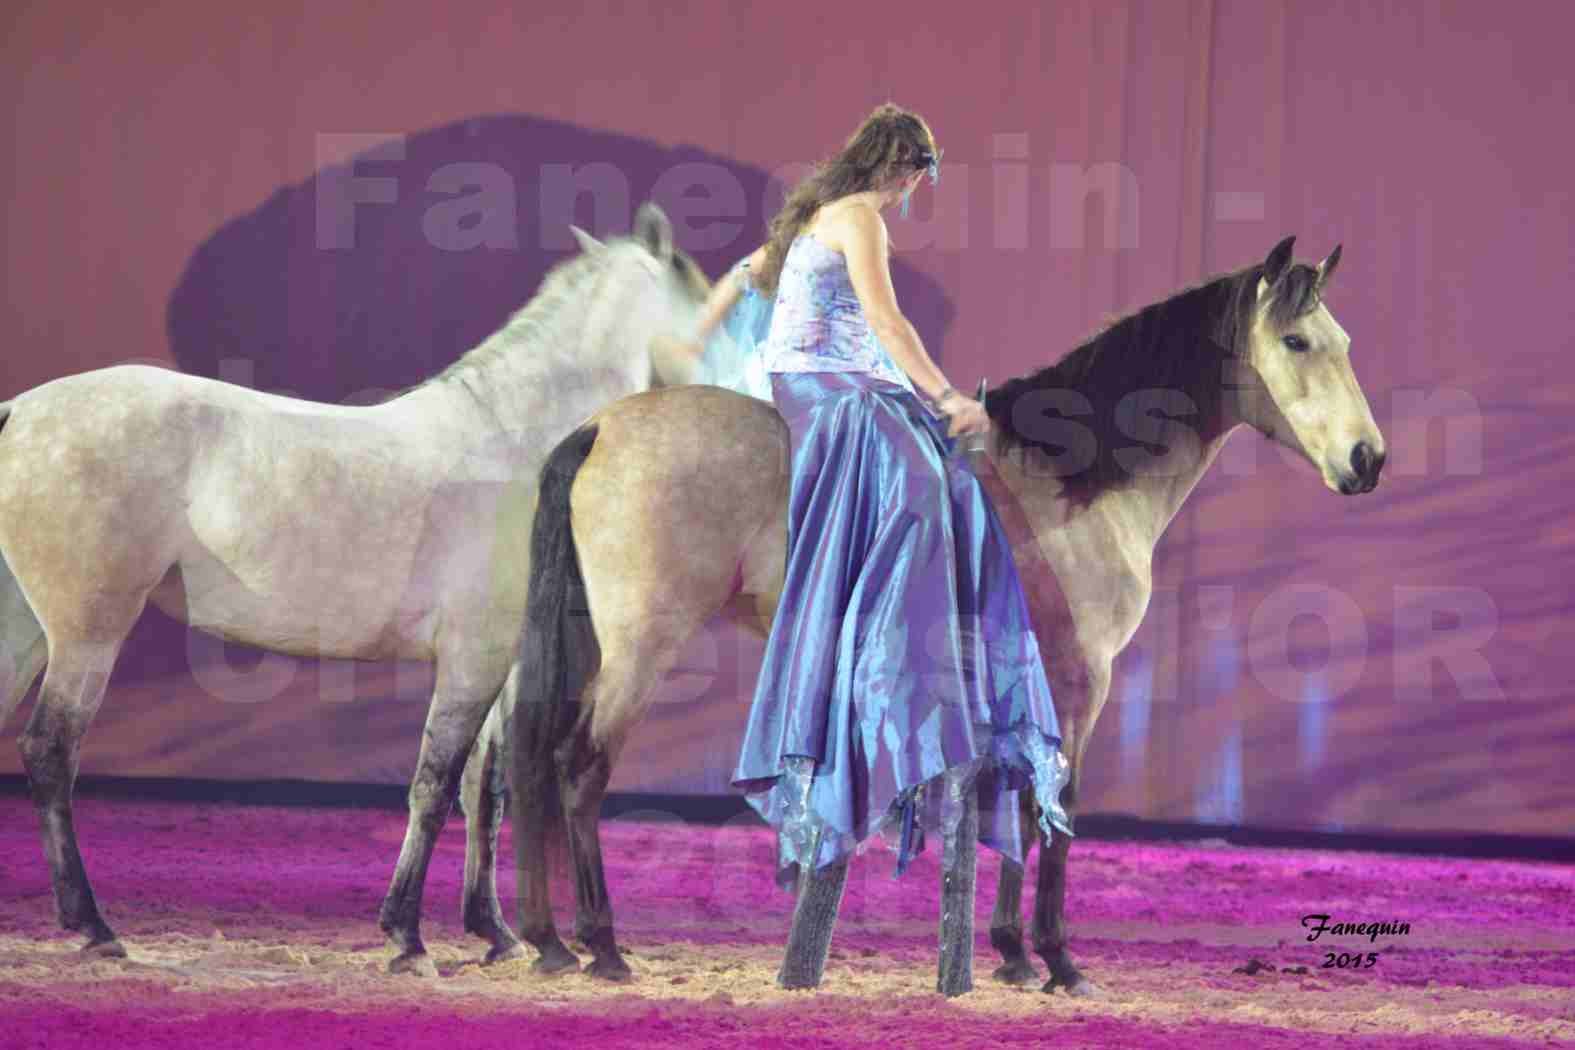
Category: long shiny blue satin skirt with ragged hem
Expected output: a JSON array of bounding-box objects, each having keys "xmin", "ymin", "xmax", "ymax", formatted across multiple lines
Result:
[{"xmin": 734, "ymin": 372, "xmax": 1060, "ymax": 885}]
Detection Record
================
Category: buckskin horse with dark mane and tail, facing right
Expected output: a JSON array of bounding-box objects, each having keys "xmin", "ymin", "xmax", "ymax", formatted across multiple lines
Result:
[{"xmin": 481, "ymin": 238, "xmax": 1384, "ymax": 995}]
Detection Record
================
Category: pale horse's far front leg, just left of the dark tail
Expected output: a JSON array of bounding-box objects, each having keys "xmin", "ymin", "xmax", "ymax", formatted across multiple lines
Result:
[{"xmin": 460, "ymin": 704, "xmax": 524, "ymax": 963}]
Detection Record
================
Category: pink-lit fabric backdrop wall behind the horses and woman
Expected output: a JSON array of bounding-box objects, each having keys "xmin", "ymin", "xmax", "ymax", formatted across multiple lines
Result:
[{"xmin": 0, "ymin": 0, "xmax": 1575, "ymax": 834}]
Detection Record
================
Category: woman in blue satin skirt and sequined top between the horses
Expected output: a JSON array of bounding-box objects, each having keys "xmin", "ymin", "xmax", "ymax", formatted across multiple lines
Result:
[{"xmin": 689, "ymin": 104, "xmax": 1069, "ymax": 992}]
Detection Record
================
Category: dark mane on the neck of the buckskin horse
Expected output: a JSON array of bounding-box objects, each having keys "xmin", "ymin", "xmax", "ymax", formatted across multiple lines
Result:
[{"xmin": 984, "ymin": 264, "xmax": 1318, "ymax": 501}]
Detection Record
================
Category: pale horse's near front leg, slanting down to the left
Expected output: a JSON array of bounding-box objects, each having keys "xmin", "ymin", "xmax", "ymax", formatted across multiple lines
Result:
[{"xmin": 380, "ymin": 660, "xmax": 499, "ymax": 976}]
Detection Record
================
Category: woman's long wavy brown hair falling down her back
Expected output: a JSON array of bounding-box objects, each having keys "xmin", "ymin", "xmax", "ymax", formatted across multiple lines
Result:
[{"xmin": 750, "ymin": 102, "xmax": 936, "ymax": 294}]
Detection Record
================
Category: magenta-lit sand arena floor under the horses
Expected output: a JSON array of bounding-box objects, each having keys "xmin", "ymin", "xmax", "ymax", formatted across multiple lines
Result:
[{"xmin": 0, "ymin": 798, "xmax": 1575, "ymax": 1050}]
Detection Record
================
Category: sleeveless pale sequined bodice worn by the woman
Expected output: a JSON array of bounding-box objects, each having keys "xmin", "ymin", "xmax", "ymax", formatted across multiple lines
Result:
[{"xmin": 743, "ymin": 233, "xmax": 914, "ymax": 390}]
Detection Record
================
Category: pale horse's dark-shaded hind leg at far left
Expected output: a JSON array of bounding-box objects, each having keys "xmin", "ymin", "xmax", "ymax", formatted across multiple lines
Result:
[{"xmin": 22, "ymin": 642, "xmax": 126, "ymax": 956}]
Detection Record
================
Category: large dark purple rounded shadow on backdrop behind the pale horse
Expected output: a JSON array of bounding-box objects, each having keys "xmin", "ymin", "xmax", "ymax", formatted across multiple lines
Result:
[{"xmin": 115, "ymin": 113, "xmax": 954, "ymax": 705}]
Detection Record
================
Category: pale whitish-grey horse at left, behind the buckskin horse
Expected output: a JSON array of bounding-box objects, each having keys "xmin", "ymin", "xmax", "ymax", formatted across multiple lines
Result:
[{"xmin": 0, "ymin": 205, "xmax": 724, "ymax": 973}]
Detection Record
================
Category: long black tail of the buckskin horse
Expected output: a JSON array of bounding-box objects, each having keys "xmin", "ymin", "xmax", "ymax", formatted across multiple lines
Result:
[{"xmin": 509, "ymin": 423, "xmax": 600, "ymax": 860}]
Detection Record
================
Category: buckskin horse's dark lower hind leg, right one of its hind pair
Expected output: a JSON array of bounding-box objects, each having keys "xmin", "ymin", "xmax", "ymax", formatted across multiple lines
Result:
[{"xmin": 558, "ymin": 723, "xmax": 632, "ymax": 981}]
